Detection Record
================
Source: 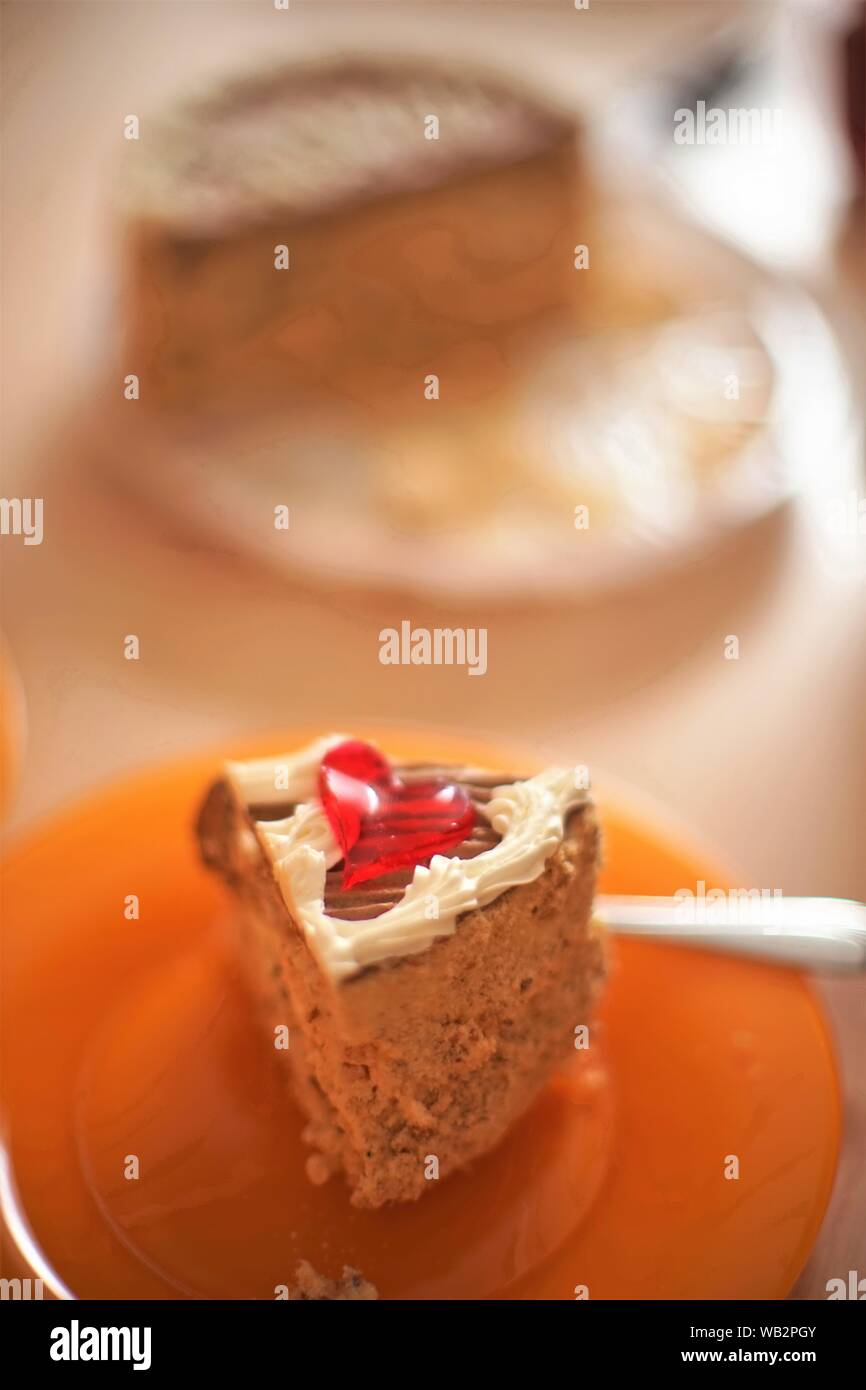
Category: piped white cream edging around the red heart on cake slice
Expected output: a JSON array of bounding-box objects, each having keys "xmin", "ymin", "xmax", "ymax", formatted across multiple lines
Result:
[{"xmin": 227, "ymin": 734, "xmax": 585, "ymax": 981}]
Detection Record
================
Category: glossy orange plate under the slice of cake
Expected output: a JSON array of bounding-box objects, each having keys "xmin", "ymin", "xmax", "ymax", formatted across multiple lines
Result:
[{"xmin": 3, "ymin": 730, "xmax": 840, "ymax": 1298}]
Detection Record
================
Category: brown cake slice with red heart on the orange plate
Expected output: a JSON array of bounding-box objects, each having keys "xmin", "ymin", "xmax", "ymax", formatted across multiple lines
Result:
[{"xmin": 197, "ymin": 735, "xmax": 603, "ymax": 1207}]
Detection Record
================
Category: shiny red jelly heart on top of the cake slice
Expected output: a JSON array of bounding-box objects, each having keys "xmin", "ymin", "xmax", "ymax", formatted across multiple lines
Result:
[{"xmin": 318, "ymin": 738, "xmax": 475, "ymax": 888}]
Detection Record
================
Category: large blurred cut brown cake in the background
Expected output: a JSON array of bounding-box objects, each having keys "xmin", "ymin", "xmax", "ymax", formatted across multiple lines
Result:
[{"xmin": 118, "ymin": 58, "xmax": 577, "ymax": 425}]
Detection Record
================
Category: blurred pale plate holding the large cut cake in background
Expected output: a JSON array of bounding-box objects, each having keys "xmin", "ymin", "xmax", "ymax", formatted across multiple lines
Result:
[{"xmin": 93, "ymin": 200, "xmax": 856, "ymax": 602}]
